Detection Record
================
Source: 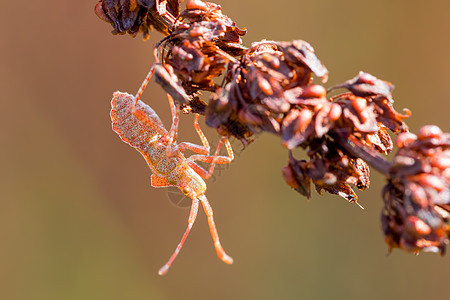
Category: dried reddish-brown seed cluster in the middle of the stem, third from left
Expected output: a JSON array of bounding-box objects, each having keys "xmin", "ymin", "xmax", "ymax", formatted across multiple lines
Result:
[{"xmin": 206, "ymin": 41, "xmax": 327, "ymax": 138}]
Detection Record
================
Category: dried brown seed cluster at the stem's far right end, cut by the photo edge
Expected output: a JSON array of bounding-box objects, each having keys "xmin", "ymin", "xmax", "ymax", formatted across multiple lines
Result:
[{"xmin": 381, "ymin": 125, "xmax": 450, "ymax": 254}]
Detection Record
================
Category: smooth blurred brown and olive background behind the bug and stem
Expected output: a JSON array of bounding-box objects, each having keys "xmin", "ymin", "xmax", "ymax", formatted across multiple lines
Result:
[{"xmin": 0, "ymin": 0, "xmax": 450, "ymax": 300}]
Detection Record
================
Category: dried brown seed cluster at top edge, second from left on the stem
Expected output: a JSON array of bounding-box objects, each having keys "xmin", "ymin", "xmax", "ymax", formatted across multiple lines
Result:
[{"xmin": 156, "ymin": 0, "xmax": 246, "ymax": 95}]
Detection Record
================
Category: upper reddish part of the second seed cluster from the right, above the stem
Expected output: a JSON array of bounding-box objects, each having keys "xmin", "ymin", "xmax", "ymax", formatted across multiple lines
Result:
[{"xmin": 281, "ymin": 72, "xmax": 410, "ymax": 153}]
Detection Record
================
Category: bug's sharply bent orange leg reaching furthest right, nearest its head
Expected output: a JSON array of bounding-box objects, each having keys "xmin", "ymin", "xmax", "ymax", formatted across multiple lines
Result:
[{"xmin": 188, "ymin": 138, "xmax": 234, "ymax": 179}]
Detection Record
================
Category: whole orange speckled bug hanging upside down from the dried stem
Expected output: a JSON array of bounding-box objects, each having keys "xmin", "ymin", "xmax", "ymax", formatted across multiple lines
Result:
[{"xmin": 111, "ymin": 67, "xmax": 234, "ymax": 275}]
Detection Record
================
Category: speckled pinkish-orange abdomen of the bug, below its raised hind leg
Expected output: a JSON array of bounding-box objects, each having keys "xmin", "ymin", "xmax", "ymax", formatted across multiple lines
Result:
[{"xmin": 111, "ymin": 92, "xmax": 167, "ymax": 153}]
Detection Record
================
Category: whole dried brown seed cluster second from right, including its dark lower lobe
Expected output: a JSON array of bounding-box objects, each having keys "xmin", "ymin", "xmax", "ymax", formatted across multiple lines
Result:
[{"xmin": 281, "ymin": 72, "xmax": 409, "ymax": 202}]
